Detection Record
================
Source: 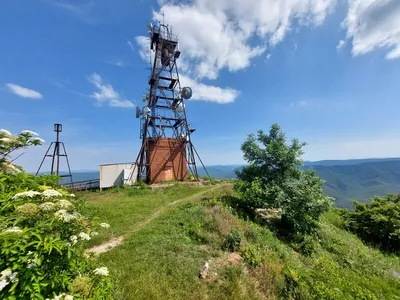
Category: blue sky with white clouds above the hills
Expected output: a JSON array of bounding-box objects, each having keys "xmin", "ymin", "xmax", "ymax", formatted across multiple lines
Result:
[{"xmin": 0, "ymin": 0, "xmax": 400, "ymax": 171}]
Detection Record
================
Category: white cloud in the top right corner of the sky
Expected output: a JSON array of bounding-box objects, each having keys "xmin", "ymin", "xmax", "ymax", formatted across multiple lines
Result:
[{"xmin": 343, "ymin": 0, "xmax": 400, "ymax": 59}]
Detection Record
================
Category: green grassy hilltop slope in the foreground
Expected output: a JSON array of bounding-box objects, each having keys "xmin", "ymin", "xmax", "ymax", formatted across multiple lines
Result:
[{"xmin": 83, "ymin": 186, "xmax": 400, "ymax": 300}]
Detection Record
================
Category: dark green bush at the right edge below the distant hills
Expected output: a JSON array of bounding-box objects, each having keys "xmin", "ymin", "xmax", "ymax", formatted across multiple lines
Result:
[{"xmin": 347, "ymin": 194, "xmax": 400, "ymax": 254}]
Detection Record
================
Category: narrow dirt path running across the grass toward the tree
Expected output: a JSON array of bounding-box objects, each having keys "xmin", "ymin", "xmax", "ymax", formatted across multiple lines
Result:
[{"xmin": 86, "ymin": 184, "xmax": 229, "ymax": 254}]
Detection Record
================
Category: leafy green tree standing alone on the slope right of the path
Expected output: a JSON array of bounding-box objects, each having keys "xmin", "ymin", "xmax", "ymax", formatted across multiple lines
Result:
[{"xmin": 235, "ymin": 124, "xmax": 331, "ymax": 237}]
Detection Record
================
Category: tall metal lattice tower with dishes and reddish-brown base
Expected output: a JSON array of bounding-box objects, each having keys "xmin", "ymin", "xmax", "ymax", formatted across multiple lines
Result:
[{"xmin": 136, "ymin": 23, "xmax": 208, "ymax": 183}]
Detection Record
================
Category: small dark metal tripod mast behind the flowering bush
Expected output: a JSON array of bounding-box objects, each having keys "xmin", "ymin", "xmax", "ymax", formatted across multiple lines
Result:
[{"xmin": 36, "ymin": 124, "xmax": 73, "ymax": 184}]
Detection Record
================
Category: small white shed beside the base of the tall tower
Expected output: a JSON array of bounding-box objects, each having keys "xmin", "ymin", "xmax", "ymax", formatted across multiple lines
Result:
[{"xmin": 100, "ymin": 163, "xmax": 137, "ymax": 189}]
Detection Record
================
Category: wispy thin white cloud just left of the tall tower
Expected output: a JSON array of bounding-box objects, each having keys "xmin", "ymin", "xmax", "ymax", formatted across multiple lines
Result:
[{"xmin": 88, "ymin": 73, "xmax": 134, "ymax": 108}]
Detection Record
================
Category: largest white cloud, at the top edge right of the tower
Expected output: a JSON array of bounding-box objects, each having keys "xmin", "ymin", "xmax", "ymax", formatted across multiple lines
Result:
[{"xmin": 153, "ymin": 0, "xmax": 336, "ymax": 79}]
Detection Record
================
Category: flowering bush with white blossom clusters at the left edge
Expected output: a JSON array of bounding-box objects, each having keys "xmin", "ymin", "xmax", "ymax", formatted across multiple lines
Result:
[{"xmin": 0, "ymin": 130, "xmax": 112, "ymax": 300}]
